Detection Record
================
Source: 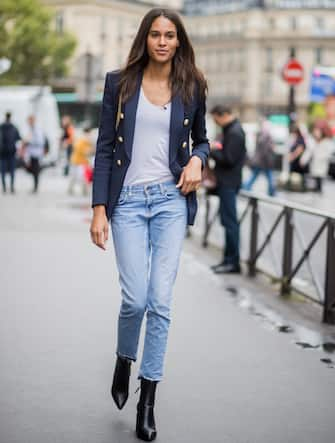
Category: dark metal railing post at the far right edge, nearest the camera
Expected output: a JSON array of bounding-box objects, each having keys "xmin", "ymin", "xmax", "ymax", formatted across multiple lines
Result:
[{"xmin": 323, "ymin": 219, "xmax": 335, "ymax": 324}]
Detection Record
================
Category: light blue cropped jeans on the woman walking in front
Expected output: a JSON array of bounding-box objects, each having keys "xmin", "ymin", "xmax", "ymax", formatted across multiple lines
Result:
[{"xmin": 111, "ymin": 181, "xmax": 187, "ymax": 381}]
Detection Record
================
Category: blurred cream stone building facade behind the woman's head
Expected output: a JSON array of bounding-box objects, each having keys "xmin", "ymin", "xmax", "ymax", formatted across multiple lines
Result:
[{"xmin": 44, "ymin": 0, "xmax": 335, "ymax": 121}]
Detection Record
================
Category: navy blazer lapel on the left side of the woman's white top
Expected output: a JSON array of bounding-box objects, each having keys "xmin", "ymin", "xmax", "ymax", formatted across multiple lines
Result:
[{"xmin": 123, "ymin": 72, "xmax": 143, "ymax": 160}]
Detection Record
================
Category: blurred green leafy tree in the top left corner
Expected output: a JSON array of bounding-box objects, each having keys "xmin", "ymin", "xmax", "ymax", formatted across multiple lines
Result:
[{"xmin": 0, "ymin": 0, "xmax": 76, "ymax": 85}]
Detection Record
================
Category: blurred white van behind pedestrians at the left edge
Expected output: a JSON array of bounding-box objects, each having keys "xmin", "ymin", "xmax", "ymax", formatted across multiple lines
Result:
[{"xmin": 0, "ymin": 86, "xmax": 61, "ymax": 162}]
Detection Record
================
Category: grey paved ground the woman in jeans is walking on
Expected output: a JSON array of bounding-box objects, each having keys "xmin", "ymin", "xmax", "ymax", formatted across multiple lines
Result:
[{"xmin": 0, "ymin": 171, "xmax": 335, "ymax": 443}]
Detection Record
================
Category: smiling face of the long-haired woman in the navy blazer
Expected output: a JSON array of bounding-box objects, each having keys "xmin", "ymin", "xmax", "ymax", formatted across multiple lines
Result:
[{"xmin": 147, "ymin": 16, "xmax": 179, "ymax": 63}]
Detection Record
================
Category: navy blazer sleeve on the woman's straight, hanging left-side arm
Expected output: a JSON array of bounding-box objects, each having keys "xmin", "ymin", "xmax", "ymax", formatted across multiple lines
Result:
[{"xmin": 92, "ymin": 73, "xmax": 117, "ymax": 207}]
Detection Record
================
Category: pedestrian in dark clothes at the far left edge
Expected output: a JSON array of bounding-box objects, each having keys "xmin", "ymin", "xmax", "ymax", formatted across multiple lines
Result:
[{"xmin": 0, "ymin": 112, "xmax": 21, "ymax": 194}]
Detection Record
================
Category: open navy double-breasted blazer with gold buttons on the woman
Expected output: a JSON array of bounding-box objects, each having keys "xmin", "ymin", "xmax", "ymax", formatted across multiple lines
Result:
[{"xmin": 92, "ymin": 71, "xmax": 209, "ymax": 225}]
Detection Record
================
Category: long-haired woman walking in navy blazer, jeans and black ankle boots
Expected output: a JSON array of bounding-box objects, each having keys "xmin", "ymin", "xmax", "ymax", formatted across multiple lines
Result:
[{"xmin": 90, "ymin": 8, "xmax": 209, "ymax": 441}]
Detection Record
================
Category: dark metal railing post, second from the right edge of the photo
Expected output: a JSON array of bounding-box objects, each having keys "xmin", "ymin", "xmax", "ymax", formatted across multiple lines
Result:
[{"xmin": 280, "ymin": 208, "xmax": 294, "ymax": 295}]
